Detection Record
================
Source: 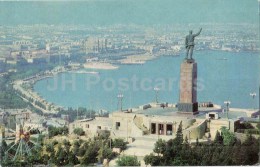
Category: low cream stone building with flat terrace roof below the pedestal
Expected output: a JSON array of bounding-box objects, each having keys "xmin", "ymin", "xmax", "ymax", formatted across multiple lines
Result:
[{"xmin": 70, "ymin": 104, "xmax": 253, "ymax": 140}]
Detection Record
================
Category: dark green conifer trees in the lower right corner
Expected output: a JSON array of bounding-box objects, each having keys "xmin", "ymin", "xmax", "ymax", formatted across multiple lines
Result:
[{"xmin": 144, "ymin": 121, "xmax": 259, "ymax": 166}]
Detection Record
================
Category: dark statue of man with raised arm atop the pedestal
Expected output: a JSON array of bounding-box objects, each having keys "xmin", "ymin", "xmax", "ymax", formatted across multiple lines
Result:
[{"xmin": 185, "ymin": 28, "xmax": 202, "ymax": 59}]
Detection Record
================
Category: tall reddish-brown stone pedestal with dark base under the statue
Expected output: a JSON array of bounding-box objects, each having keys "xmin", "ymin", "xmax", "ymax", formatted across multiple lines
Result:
[{"xmin": 177, "ymin": 59, "xmax": 198, "ymax": 114}]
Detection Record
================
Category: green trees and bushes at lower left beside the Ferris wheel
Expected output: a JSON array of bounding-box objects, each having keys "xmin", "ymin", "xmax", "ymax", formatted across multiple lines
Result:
[{"xmin": 1, "ymin": 132, "xmax": 125, "ymax": 166}]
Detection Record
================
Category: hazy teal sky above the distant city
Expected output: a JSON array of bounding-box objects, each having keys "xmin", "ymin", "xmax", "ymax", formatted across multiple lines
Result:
[{"xmin": 0, "ymin": 0, "xmax": 258, "ymax": 25}]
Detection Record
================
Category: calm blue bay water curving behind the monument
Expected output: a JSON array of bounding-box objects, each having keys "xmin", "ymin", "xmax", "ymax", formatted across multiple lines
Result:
[{"xmin": 34, "ymin": 50, "xmax": 260, "ymax": 111}]
